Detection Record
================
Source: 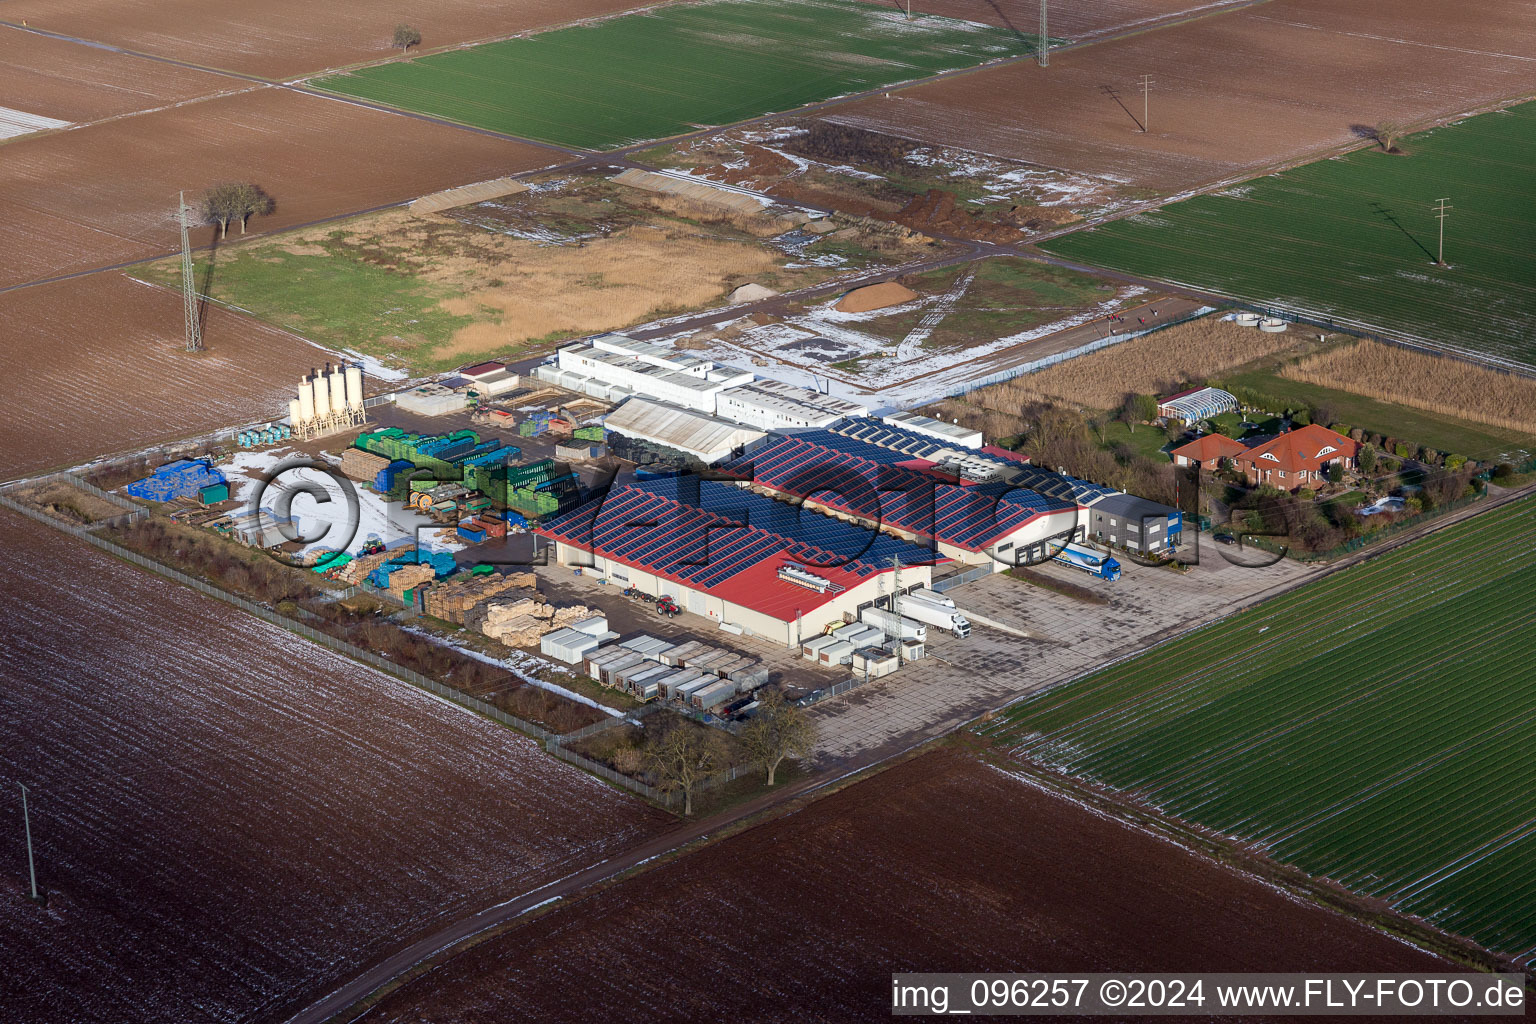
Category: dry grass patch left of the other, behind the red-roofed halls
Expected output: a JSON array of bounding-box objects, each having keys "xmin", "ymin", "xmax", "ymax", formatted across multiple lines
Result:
[{"xmin": 969, "ymin": 316, "xmax": 1296, "ymax": 410}]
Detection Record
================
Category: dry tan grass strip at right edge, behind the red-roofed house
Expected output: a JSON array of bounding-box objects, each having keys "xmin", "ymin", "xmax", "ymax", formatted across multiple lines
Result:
[{"xmin": 1281, "ymin": 341, "xmax": 1536, "ymax": 433}]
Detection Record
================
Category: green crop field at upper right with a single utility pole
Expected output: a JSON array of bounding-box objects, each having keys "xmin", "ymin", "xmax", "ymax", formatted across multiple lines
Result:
[{"xmin": 1044, "ymin": 103, "xmax": 1536, "ymax": 364}]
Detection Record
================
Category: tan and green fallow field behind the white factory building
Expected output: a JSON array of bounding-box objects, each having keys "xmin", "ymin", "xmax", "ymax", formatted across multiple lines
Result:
[{"xmin": 135, "ymin": 173, "xmax": 922, "ymax": 372}]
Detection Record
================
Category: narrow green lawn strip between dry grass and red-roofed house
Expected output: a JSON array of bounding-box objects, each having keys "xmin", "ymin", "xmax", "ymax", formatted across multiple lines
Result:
[{"xmin": 1221, "ymin": 370, "xmax": 1531, "ymax": 461}]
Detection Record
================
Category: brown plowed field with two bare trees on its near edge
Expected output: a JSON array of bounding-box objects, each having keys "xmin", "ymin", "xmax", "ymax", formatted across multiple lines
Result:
[{"xmin": 0, "ymin": 88, "xmax": 558, "ymax": 287}]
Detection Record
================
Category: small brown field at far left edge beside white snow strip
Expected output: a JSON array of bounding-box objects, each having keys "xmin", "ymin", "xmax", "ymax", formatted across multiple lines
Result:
[{"xmin": 0, "ymin": 26, "xmax": 236, "ymax": 121}]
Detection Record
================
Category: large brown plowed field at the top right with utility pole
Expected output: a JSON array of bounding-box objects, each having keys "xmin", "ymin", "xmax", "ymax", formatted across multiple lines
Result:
[{"xmin": 828, "ymin": 0, "xmax": 1536, "ymax": 195}]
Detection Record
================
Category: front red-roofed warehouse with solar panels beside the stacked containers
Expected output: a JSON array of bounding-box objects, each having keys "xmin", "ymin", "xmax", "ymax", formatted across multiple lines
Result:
[{"xmin": 538, "ymin": 477, "xmax": 943, "ymax": 646}]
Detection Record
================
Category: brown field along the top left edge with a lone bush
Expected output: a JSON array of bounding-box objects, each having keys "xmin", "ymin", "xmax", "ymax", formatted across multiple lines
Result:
[{"xmin": 5, "ymin": 0, "xmax": 654, "ymax": 78}]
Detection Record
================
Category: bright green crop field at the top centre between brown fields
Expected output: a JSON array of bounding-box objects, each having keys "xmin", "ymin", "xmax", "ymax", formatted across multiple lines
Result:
[{"xmin": 312, "ymin": 0, "xmax": 1035, "ymax": 149}]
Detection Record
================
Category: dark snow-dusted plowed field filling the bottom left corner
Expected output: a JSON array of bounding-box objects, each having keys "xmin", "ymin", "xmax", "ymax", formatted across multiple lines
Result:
[{"xmin": 0, "ymin": 511, "xmax": 671, "ymax": 1024}]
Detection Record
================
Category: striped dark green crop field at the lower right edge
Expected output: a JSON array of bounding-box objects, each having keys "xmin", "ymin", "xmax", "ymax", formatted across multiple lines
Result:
[{"xmin": 985, "ymin": 499, "xmax": 1536, "ymax": 964}]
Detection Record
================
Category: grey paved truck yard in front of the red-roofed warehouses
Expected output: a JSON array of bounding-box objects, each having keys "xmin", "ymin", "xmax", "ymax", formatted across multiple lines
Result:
[{"xmin": 813, "ymin": 545, "xmax": 1319, "ymax": 766}]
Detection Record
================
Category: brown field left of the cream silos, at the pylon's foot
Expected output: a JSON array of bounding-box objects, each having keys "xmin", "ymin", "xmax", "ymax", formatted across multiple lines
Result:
[{"xmin": 0, "ymin": 273, "xmax": 330, "ymax": 479}]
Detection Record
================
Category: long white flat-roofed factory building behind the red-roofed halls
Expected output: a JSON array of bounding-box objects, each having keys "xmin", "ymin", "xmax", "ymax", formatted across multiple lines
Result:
[{"xmin": 535, "ymin": 335, "xmax": 868, "ymax": 430}]
